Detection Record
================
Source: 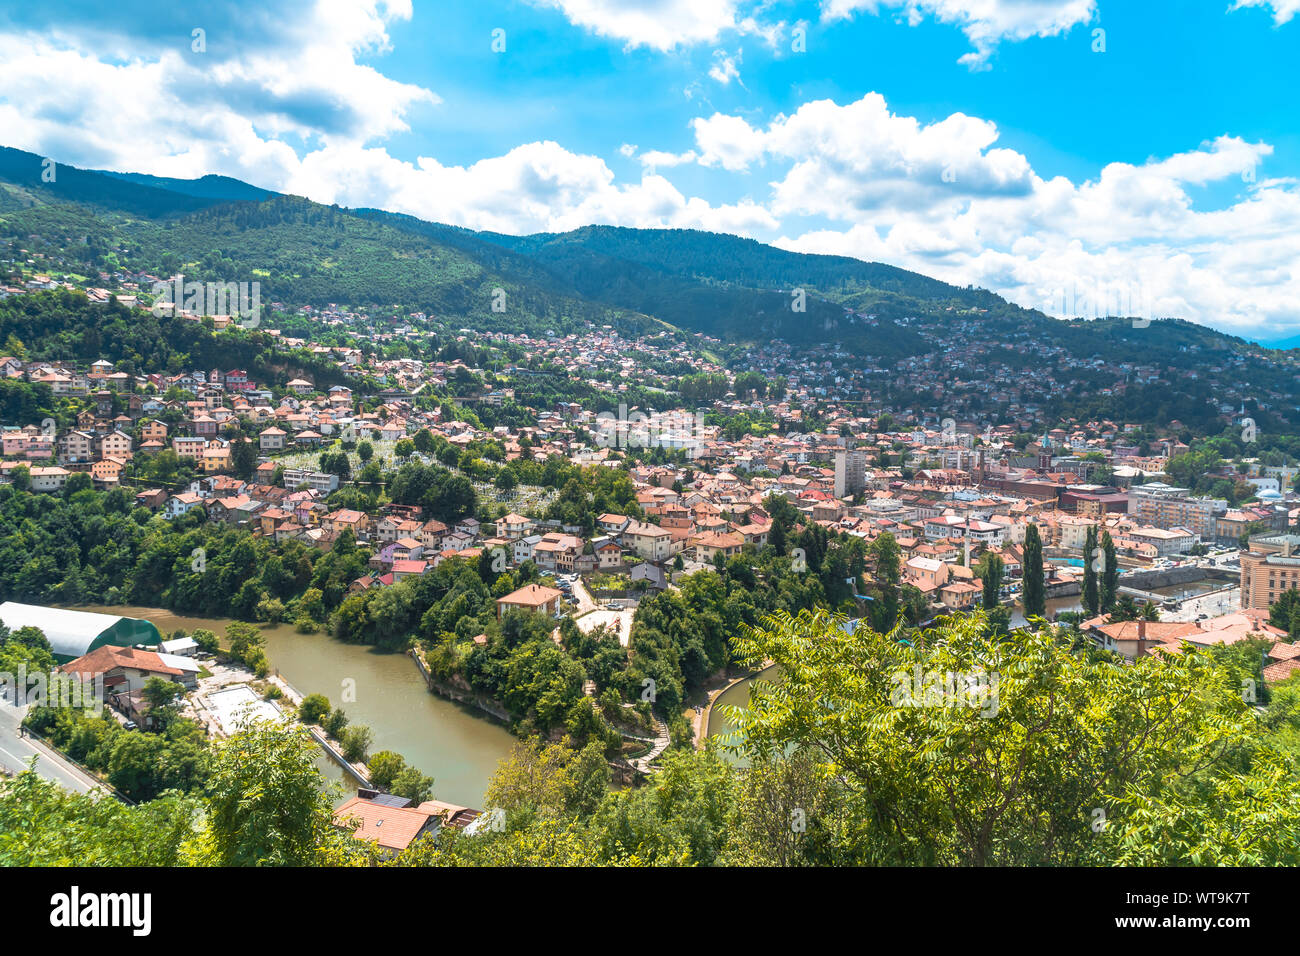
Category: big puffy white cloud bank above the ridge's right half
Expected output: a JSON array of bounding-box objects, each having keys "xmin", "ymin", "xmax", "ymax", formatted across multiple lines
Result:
[{"xmin": 694, "ymin": 94, "xmax": 1300, "ymax": 337}]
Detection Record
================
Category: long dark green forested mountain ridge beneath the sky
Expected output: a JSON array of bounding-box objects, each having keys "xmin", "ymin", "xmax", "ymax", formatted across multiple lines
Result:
[{"xmin": 0, "ymin": 147, "xmax": 1284, "ymax": 360}]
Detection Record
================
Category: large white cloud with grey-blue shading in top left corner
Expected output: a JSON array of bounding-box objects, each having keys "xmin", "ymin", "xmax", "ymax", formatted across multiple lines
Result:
[{"xmin": 0, "ymin": 0, "xmax": 438, "ymax": 179}]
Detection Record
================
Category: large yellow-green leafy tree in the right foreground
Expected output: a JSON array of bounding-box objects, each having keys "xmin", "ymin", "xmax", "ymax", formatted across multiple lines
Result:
[{"xmin": 733, "ymin": 611, "xmax": 1300, "ymax": 865}]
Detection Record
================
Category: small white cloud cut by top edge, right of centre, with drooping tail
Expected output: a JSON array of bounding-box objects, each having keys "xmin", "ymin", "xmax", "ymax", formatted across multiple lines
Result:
[{"xmin": 822, "ymin": 0, "xmax": 1097, "ymax": 69}]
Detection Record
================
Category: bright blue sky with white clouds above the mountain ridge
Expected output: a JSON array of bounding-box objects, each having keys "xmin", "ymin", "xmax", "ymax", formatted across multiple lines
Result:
[{"xmin": 0, "ymin": 0, "xmax": 1300, "ymax": 342}]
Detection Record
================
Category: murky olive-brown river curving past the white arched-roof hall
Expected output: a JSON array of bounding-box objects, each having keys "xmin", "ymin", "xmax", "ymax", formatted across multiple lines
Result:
[{"xmin": 78, "ymin": 605, "xmax": 515, "ymax": 808}]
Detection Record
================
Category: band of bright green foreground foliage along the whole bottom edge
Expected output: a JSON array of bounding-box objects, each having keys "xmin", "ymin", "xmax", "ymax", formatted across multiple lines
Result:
[{"xmin": 0, "ymin": 611, "xmax": 1300, "ymax": 866}]
